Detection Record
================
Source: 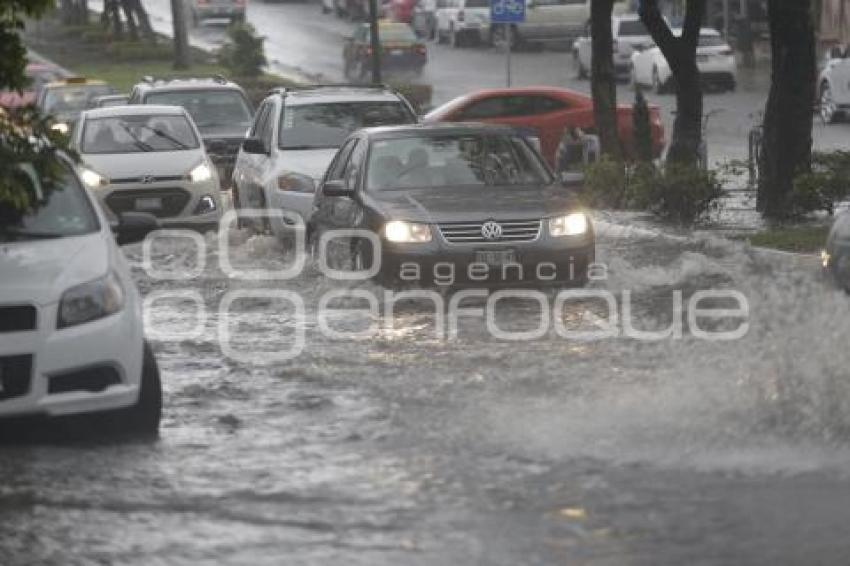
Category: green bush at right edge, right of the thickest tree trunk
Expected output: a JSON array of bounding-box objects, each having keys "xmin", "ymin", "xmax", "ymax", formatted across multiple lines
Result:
[{"xmin": 787, "ymin": 150, "xmax": 850, "ymax": 218}]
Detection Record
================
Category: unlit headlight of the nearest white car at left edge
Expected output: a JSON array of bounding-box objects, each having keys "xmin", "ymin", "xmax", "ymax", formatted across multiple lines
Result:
[{"xmin": 56, "ymin": 273, "xmax": 124, "ymax": 328}]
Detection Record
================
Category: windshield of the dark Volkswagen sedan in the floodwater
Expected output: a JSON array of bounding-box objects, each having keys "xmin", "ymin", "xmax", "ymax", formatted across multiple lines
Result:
[{"xmin": 367, "ymin": 134, "xmax": 552, "ymax": 190}]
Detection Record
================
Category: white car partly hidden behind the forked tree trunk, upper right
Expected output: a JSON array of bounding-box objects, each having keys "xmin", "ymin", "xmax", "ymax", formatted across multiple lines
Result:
[{"xmin": 632, "ymin": 28, "xmax": 738, "ymax": 94}]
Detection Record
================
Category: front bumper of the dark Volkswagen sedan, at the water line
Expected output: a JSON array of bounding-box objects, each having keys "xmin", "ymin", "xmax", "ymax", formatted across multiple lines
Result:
[{"xmin": 380, "ymin": 232, "xmax": 596, "ymax": 287}]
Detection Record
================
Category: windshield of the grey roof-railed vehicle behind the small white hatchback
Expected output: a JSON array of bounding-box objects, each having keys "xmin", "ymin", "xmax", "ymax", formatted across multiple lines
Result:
[{"xmin": 145, "ymin": 90, "xmax": 251, "ymax": 129}]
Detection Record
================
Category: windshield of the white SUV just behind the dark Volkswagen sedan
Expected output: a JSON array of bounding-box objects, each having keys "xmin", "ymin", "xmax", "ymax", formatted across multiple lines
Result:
[{"xmin": 279, "ymin": 102, "xmax": 416, "ymax": 149}]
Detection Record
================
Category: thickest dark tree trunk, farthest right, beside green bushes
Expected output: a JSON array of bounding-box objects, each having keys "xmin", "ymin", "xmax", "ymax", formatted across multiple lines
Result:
[{"xmin": 758, "ymin": 0, "xmax": 817, "ymax": 219}]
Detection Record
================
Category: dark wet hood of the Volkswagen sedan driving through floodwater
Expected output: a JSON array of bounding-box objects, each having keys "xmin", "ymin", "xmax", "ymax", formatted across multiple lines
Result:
[{"xmin": 364, "ymin": 185, "xmax": 578, "ymax": 224}]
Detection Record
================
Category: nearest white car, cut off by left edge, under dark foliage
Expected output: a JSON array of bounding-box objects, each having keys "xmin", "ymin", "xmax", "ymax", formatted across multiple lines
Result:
[{"xmin": 0, "ymin": 156, "xmax": 162, "ymax": 436}]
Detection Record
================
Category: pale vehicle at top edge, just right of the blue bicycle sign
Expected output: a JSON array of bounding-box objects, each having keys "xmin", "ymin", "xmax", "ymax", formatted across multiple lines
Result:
[{"xmin": 491, "ymin": 0, "xmax": 629, "ymax": 48}]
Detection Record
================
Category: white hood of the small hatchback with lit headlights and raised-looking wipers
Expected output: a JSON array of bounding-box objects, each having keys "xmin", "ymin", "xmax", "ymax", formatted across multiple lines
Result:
[{"xmin": 82, "ymin": 150, "xmax": 203, "ymax": 179}]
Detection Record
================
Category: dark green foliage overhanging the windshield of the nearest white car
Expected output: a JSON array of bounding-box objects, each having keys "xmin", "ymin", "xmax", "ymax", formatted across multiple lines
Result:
[{"xmin": 0, "ymin": 107, "xmax": 77, "ymax": 222}]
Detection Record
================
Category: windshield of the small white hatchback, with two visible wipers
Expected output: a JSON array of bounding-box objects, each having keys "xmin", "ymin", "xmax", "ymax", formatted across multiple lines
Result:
[{"xmin": 80, "ymin": 115, "xmax": 199, "ymax": 154}]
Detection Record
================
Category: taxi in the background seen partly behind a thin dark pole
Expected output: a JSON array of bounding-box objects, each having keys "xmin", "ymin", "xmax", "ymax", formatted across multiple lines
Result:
[{"xmin": 342, "ymin": 22, "xmax": 428, "ymax": 82}]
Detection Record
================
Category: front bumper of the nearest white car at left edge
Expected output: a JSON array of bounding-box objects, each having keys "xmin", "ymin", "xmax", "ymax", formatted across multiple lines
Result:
[{"xmin": 0, "ymin": 303, "xmax": 143, "ymax": 417}]
